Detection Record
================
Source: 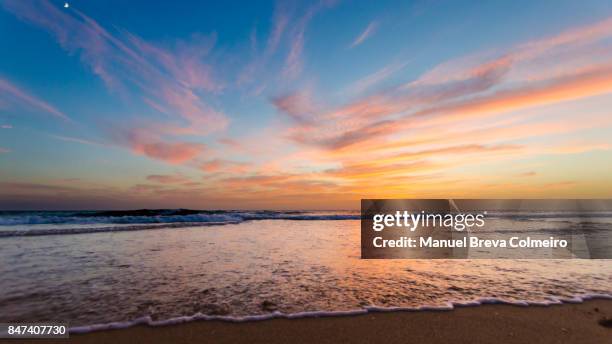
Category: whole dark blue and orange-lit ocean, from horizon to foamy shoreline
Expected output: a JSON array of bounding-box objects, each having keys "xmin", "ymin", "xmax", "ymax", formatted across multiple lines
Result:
[{"xmin": 0, "ymin": 210, "xmax": 612, "ymax": 332}]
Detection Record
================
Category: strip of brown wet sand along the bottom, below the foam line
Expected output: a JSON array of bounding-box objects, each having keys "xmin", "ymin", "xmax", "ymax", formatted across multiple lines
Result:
[{"xmin": 8, "ymin": 300, "xmax": 612, "ymax": 344}]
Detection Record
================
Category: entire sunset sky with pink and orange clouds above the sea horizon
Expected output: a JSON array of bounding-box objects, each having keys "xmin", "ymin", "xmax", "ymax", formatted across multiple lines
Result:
[{"xmin": 0, "ymin": 0, "xmax": 612, "ymax": 210}]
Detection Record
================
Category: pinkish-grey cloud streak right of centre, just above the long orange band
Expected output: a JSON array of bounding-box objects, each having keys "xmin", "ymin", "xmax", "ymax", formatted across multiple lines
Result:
[{"xmin": 273, "ymin": 51, "xmax": 508, "ymax": 147}]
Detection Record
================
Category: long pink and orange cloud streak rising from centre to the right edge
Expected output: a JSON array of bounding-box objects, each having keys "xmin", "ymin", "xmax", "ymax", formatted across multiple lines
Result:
[{"xmin": 275, "ymin": 15, "xmax": 612, "ymax": 144}]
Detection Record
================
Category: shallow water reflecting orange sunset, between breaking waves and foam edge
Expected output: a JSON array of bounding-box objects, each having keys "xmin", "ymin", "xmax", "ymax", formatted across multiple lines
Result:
[{"xmin": 0, "ymin": 220, "xmax": 612, "ymax": 325}]
